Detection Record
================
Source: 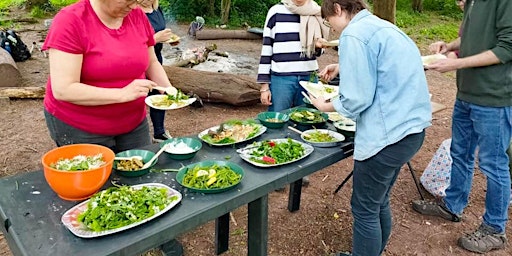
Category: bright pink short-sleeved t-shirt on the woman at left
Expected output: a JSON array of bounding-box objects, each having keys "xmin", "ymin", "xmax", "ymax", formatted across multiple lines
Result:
[{"xmin": 43, "ymin": 0, "xmax": 155, "ymax": 135}]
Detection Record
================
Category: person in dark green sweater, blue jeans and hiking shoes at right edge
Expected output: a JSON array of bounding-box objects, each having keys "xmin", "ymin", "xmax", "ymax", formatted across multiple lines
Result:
[{"xmin": 412, "ymin": 0, "xmax": 512, "ymax": 253}]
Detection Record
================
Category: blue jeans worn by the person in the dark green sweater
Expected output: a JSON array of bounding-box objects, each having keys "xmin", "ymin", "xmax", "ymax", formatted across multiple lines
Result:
[{"xmin": 444, "ymin": 99, "xmax": 512, "ymax": 233}]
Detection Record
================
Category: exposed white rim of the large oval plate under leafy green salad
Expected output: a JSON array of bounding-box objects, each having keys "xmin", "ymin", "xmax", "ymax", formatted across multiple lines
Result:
[{"xmin": 61, "ymin": 183, "xmax": 182, "ymax": 238}]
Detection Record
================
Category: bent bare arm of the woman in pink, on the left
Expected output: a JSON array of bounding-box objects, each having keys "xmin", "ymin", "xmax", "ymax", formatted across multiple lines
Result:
[{"xmin": 49, "ymin": 48, "xmax": 153, "ymax": 106}]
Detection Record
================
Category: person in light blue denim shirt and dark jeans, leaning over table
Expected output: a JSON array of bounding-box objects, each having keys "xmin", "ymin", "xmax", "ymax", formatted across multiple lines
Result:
[{"xmin": 312, "ymin": 0, "xmax": 432, "ymax": 256}]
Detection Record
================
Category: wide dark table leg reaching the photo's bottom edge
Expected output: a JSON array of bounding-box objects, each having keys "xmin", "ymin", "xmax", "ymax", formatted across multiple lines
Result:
[{"xmin": 247, "ymin": 195, "xmax": 268, "ymax": 256}]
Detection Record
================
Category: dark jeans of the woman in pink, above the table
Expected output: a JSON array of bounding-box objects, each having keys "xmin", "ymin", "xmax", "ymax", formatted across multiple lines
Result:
[{"xmin": 44, "ymin": 109, "xmax": 151, "ymax": 152}]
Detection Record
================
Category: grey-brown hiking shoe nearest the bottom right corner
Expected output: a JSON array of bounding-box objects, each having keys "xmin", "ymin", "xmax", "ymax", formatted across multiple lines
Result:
[{"xmin": 458, "ymin": 223, "xmax": 507, "ymax": 253}]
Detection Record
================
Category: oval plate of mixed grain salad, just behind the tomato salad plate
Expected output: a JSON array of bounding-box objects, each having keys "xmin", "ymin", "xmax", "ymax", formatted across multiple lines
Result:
[{"xmin": 197, "ymin": 119, "xmax": 267, "ymax": 146}]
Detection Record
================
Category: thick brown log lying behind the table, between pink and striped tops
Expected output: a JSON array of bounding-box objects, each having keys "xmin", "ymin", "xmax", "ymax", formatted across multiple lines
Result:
[{"xmin": 164, "ymin": 66, "xmax": 261, "ymax": 106}]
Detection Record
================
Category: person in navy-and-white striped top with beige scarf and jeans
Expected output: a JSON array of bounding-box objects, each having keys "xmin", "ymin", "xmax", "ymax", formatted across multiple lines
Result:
[{"xmin": 257, "ymin": 0, "xmax": 329, "ymax": 111}]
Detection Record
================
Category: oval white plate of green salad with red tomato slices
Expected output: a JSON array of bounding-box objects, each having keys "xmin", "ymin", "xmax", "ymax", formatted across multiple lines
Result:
[{"xmin": 237, "ymin": 138, "xmax": 314, "ymax": 167}]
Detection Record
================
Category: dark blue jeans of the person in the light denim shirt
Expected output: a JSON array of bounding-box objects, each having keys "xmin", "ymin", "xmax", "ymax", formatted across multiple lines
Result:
[{"xmin": 350, "ymin": 131, "xmax": 425, "ymax": 256}]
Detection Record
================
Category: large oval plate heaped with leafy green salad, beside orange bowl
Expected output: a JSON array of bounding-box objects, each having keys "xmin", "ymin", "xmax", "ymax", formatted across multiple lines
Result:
[{"xmin": 61, "ymin": 183, "xmax": 182, "ymax": 238}]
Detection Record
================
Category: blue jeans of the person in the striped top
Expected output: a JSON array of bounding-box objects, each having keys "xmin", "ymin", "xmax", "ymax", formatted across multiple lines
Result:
[{"xmin": 268, "ymin": 75, "xmax": 317, "ymax": 112}]
